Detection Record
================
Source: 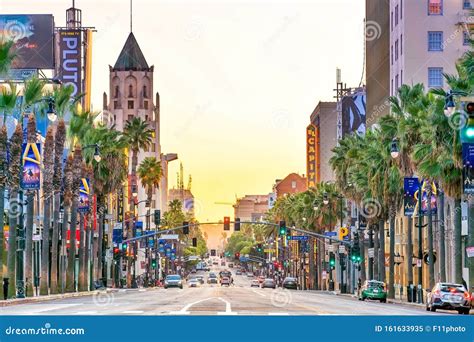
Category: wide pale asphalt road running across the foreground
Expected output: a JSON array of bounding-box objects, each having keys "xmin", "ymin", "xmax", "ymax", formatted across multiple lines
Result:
[{"xmin": 0, "ymin": 268, "xmax": 466, "ymax": 316}]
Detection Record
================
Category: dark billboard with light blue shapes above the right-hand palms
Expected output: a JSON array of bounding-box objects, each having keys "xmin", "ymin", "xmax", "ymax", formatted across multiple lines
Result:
[{"xmin": 341, "ymin": 91, "xmax": 366, "ymax": 137}]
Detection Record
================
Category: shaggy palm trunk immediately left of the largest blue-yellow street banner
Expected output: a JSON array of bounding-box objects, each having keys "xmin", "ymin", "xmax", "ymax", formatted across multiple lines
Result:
[{"xmin": 7, "ymin": 125, "xmax": 23, "ymax": 298}]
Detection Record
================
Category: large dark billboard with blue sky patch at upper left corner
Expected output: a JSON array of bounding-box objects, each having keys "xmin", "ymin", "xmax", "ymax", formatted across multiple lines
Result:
[{"xmin": 0, "ymin": 14, "xmax": 54, "ymax": 69}]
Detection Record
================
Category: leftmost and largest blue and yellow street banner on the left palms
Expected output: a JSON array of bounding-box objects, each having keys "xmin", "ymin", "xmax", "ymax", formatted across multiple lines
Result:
[{"xmin": 21, "ymin": 143, "xmax": 41, "ymax": 190}]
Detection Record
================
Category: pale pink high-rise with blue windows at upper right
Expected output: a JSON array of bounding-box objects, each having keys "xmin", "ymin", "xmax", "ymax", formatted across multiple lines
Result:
[{"xmin": 388, "ymin": 0, "xmax": 471, "ymax": 95}]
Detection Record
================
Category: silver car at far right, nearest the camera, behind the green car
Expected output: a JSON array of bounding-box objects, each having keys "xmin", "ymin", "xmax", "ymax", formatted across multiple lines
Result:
[{"xmin": 426, "ymin": 283, "xmax": 471, "ymax": 315}]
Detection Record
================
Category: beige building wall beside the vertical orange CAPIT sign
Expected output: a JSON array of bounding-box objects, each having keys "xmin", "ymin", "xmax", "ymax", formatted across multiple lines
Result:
[{"xmin": 310, "ymin": 102, "xmax": 337, "ymax": 182}]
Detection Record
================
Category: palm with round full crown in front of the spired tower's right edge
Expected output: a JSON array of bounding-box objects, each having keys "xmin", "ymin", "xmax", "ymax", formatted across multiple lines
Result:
[{"xmin": 123, "ymin": 117, "xmax": 154, "ymax": 287}]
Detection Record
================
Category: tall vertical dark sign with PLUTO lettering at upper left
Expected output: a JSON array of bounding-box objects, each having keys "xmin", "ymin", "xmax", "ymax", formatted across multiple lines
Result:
[{"xmin": 57, "ymin": 29, "xmax": 82, "ymax": 96}]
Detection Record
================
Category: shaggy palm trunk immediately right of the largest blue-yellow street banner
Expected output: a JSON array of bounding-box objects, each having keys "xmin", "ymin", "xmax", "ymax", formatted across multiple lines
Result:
[{"xmin": 40, "ymin": 126, "xmax": 54, "ymax": 295}]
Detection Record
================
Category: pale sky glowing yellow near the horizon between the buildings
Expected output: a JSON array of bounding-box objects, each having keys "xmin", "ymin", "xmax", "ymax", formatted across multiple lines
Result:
[{"xmin": 0, "ymin": 0, "xmax": 364, "ymax": 221}]
